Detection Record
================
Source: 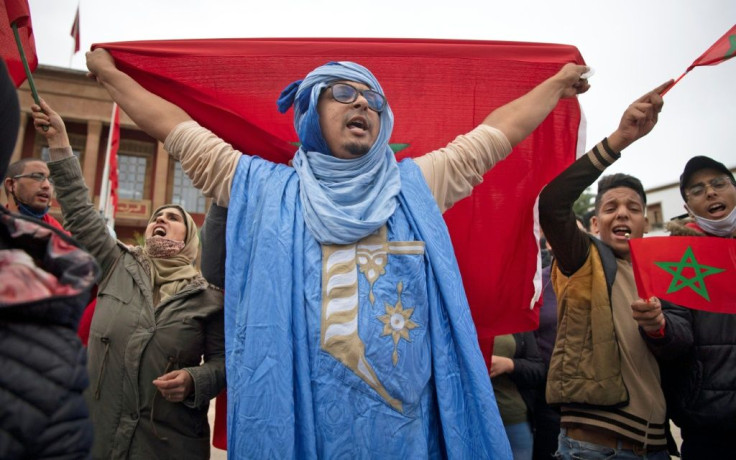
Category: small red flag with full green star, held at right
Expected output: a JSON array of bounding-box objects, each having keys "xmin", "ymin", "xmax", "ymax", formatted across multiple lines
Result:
[{"xmin": 629, "ymin": 236, "xmax": 736, "ymax": 313}]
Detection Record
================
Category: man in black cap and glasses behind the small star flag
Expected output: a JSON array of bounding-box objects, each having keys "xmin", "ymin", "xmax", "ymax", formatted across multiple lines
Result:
[{"xmin": 632, "ymin": 156, "xmax": 736, "ymax": 460}]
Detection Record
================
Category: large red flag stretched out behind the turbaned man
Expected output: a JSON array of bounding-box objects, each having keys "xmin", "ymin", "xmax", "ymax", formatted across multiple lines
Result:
[{"xmin": 95, "ymin": 39, "xmax": 583, "ymax": 360}]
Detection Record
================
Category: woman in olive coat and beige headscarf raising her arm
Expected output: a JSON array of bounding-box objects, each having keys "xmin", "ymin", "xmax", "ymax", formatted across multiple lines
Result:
[{"xmin": 31, "ymin": 100, "xmax": 225, "ymax": 460}]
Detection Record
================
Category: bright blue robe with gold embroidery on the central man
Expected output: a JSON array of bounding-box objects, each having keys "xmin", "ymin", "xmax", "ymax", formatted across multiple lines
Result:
[{"xmin": 225, "ymin": 156, "xmax": 511, "ymax": 459}]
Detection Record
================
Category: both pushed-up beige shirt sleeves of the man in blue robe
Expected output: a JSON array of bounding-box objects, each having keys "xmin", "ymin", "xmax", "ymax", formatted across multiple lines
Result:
[{"xmin": 164, "ymin": 121, "xmax": 511, "ymax": 212}]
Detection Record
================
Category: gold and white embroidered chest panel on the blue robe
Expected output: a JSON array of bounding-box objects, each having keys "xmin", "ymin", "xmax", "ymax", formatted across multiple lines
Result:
[{"xmin": 319, "ymin": 226, "xmax": 431, "ymax": 412}]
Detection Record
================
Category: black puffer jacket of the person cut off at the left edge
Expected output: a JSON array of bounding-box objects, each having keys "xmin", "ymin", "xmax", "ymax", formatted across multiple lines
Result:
[{"xmin": 0, "ymin": 207, "xmax": 98, "ymax": 459}]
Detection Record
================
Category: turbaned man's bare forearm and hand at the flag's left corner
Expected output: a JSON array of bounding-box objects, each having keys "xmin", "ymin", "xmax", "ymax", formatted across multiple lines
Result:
[{"xmin": 87, "ymin": 48, "xmax": 191, "ymax": 142}]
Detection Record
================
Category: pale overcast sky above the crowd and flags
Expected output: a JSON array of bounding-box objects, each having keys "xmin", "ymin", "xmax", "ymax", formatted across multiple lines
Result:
[{"xmin": 29, "ymin": 0, "xmax": 736, "ymax": 188}]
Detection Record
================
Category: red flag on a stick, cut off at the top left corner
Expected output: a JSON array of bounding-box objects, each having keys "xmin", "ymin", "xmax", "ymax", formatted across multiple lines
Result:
[{"xmin": 0, "ymin": 0, "xmax": 38, "ymax": 87}]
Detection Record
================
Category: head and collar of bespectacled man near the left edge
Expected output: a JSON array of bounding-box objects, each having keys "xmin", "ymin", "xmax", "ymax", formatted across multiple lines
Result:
[{"xmin": 3, "ymin": 158, "xmax": 69, "ymax": 235}]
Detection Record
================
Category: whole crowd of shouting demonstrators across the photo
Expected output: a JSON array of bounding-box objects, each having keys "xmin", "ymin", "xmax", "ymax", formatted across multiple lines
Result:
[{"xmin": 0, "ymin": 49, "xmax": 736, "ymax": 460}]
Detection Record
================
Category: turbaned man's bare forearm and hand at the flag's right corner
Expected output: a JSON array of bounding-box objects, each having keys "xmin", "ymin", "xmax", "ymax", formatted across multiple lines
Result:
[{"xmin": 483, "ymin": 64, "xmax": 590, "ymax": 147}]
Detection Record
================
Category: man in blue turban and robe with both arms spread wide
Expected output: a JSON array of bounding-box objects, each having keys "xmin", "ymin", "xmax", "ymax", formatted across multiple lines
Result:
[{"xmin": 87, "ymin": 49, "xmax": 588, "ymax": 458}]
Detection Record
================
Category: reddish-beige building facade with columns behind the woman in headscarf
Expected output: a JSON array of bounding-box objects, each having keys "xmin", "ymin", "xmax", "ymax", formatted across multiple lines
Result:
[{"xmin": 3, "ymin": 66, "xmax": 209, "ymax": 242}]
